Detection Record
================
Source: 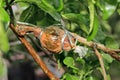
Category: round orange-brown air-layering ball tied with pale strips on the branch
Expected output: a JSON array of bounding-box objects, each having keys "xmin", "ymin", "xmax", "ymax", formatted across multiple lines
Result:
[{"xmin": 37, "ymin": 26, "xmax": 77, "ymax": 53}]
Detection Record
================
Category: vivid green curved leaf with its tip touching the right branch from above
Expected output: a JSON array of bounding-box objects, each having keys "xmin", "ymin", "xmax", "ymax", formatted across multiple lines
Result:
[{"xmin": 87, "ymin": 17, "xmax": 99, "ymax": 41}]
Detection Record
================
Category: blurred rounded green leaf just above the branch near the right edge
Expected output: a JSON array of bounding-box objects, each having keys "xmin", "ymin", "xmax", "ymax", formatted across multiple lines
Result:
[{"xmin": 105, "ymin": 37, "xmax": 119, "ymax": 49}]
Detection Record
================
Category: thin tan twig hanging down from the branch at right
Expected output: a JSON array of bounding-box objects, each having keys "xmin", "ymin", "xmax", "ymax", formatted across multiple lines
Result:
[{"xmin": 93, "ymin": 44, "xmax": 107, "ymax": 80}]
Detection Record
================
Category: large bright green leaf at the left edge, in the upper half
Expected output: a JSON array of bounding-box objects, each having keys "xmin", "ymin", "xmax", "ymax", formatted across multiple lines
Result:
[{"xmin": 0, "ymin": 7, "xmax": 10, "ymax": 52}]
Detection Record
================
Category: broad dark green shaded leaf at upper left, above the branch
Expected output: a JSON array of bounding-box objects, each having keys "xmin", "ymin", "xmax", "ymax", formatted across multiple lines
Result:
[{"xmin": 20, "ymin": 5, "xmax": 51, "ymax": 26}]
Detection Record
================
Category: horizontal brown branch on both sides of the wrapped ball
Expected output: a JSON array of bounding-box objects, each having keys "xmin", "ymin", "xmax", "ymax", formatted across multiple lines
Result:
[{"xmin": 13, "ymin": 24, "xmax": 120, "ymax": 61}]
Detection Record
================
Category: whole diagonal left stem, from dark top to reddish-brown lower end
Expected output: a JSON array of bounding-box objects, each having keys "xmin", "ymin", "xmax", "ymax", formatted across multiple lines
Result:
[{"xmin": 5, "ymin": 0, "xmax": 59, "ymax": 80}]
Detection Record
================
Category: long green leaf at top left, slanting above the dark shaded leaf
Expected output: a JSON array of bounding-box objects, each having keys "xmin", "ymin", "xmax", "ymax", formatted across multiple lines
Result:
[{"xmin": 16, "ymin": 0, "xmax": 61, "ymax": 21}]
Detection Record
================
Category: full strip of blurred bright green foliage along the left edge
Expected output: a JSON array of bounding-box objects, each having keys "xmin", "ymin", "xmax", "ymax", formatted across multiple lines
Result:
[{"xmin": 0, "ymin": 0, "xmax": 10, "ymax": 76}]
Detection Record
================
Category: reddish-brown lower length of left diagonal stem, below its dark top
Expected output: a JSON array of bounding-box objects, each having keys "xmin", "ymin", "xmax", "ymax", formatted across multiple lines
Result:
[{"xmin": 10, "ymin": 24, "xmax": 59, "ymax": 80}]
